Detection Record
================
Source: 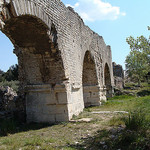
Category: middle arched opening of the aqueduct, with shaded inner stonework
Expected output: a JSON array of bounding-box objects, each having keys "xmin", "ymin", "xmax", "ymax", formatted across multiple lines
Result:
[{"xmin": 82, "ymin": 51, "xmax": 100, "ymax": 107}]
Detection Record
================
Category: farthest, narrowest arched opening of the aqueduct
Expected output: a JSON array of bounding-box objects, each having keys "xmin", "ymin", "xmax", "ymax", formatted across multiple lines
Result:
[{"xmin": 104, "ymin": 63, "xmax": 112, "ymax": 98}]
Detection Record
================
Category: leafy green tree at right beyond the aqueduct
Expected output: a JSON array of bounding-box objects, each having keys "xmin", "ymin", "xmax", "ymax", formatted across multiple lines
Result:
[{"xmin": 125, "ymin": 36, "xmax": 150, "ymax": 85}]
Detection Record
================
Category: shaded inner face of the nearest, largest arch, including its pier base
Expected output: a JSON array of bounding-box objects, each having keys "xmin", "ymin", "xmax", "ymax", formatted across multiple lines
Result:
[{"xmin": 3, "ymin": 15, "xmax": 68, "ymax": 122}]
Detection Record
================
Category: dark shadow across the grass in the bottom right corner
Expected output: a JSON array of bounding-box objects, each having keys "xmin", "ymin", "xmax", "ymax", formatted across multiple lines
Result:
[{"xmin": 60, "ymin": 128, "xmax": 150, "ymax": 150}]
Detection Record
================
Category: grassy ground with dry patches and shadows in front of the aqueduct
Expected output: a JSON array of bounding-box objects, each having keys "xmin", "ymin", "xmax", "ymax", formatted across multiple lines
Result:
[{"xmin": 0, "ymin": 82, "xmax": 150, "ymax": 150}]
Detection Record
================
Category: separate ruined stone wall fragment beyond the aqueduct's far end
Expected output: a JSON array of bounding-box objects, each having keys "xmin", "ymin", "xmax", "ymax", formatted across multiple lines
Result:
[{"xmin": 113, "ymin": 62, "xmax": 124, "ymax": 89}]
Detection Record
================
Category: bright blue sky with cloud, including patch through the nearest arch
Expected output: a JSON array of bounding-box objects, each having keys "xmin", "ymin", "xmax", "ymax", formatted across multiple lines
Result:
[{"xmin": 0, "ymin": 0, "xmax": 150, "ymax": 71}]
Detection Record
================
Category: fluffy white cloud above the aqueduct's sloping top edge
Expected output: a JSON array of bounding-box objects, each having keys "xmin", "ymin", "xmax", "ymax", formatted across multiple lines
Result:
[{"xmin": 66, "ymin": 0, "xmax": 126, "ymax": 21}]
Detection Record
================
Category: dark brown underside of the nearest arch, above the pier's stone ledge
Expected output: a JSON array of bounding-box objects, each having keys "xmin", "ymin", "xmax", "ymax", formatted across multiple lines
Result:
[{"xmin": 4, "ymin": 16, "xmax": 65, "ymax": 86}]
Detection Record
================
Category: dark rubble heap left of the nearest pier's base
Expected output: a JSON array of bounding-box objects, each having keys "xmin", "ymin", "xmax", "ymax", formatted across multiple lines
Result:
[{"xmin": 0, "ymin": 86, "xmax": 25, "ymax": 120}]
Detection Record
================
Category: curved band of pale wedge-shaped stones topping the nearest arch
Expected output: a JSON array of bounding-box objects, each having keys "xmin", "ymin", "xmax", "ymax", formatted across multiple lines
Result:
[{"xmin": 0, "ymin": 0, "xmax": 51, "ymax": 28}]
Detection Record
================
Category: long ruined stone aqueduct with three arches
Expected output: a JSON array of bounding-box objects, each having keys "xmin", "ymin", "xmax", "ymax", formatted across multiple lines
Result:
[{"xmin": 0, "ymin": 0, "xmax": 114, "ymax": 122}]
